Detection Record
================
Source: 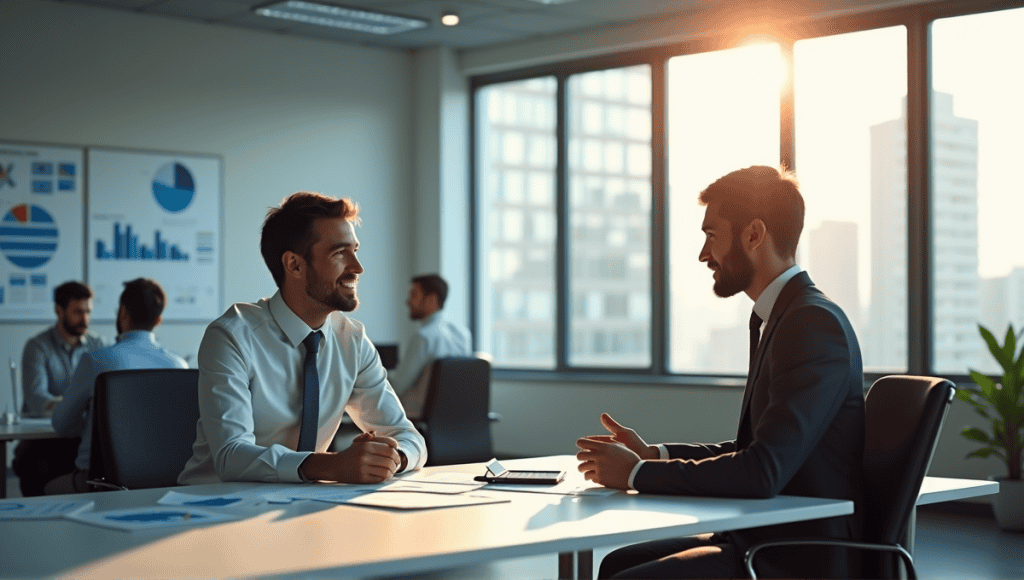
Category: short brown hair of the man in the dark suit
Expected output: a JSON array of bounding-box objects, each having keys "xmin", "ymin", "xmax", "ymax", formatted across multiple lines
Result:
[{"xmin": 697, "ymin": 165, "xmax": 804, "ymax": 257}]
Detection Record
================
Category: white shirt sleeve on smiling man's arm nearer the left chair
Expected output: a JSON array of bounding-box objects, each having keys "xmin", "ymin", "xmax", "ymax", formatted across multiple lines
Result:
[{"xmin": 199, "ymin": 323, "xmax": 309, "ymax": 483}]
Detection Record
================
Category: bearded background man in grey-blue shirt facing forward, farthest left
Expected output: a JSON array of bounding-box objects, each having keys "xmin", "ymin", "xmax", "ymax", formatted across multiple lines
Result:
[{"xmin": 12, "ymin": 282, "xmax": 110, "ymax": 497}]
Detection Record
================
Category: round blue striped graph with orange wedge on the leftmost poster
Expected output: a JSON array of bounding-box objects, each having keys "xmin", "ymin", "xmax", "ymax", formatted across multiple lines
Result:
[{"xmin": 0, "ymin": 204, "xmax": 57, "ymax": 268}]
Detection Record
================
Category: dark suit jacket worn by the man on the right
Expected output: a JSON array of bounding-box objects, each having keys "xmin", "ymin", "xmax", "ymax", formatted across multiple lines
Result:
[{"xmin": 633, "ymin": 273, "xmax": 864, "ymax": 578}]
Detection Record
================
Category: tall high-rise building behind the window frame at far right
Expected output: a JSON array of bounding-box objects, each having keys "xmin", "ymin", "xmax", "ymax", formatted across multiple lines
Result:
[{"xmin": 868, "ymin": 92, "xmax": 981, "ymax": 372}]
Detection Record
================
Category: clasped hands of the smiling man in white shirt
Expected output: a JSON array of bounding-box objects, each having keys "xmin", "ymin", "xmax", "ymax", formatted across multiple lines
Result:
[{"xmin": 299, "ymin": 431, "xmax": 406, "ymax": 484}]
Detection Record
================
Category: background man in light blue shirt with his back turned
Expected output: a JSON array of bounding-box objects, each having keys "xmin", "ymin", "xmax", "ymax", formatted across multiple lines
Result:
[{"xmin": 45, "ymin": 278, "xmax": 188, "ymax": 495}]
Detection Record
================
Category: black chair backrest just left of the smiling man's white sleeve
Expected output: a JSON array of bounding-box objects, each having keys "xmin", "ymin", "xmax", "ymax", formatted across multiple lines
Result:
[{"xmin": 89, "ymin": 369, "xmax": 199, "ymax": 489}]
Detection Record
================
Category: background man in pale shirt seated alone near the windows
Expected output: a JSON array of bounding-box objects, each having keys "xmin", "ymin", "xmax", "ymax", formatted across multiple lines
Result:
[{"xmin": 387, "ymin": 274, "xmax": 473, "ymax": 417}]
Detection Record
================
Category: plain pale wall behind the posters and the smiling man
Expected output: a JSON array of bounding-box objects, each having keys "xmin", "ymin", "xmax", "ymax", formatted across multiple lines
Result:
[{"xmin": 0, "ymin": 1, "xmax": 413, "ymax": 418}]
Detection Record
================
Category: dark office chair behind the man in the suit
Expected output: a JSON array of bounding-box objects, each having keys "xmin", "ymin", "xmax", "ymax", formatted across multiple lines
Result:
[{"xmin": 743, "ymin": 375, "xmax": 955, "ymax": 579}]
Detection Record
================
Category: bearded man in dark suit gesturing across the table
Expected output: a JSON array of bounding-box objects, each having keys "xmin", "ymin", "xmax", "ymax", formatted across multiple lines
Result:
[{"xmin": 577, "ymin": 167, "xmax": 864, "ymax": 578}]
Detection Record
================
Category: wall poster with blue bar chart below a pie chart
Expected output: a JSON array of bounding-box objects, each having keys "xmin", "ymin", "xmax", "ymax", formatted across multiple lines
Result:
[{"xmin": 87, "ymin": 148, "xmax": 221, "ymax": 321}]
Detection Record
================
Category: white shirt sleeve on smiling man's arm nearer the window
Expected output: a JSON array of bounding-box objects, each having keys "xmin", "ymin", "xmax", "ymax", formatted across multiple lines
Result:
[{"xmin": 345, "ymin": 335, "xmax": 427, "ymax": 471}]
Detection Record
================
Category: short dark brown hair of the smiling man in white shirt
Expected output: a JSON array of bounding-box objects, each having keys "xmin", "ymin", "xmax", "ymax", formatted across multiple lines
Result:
[{"xmin": 260, "ymin": 192, "xmax": 359, "ymax": 288}]
